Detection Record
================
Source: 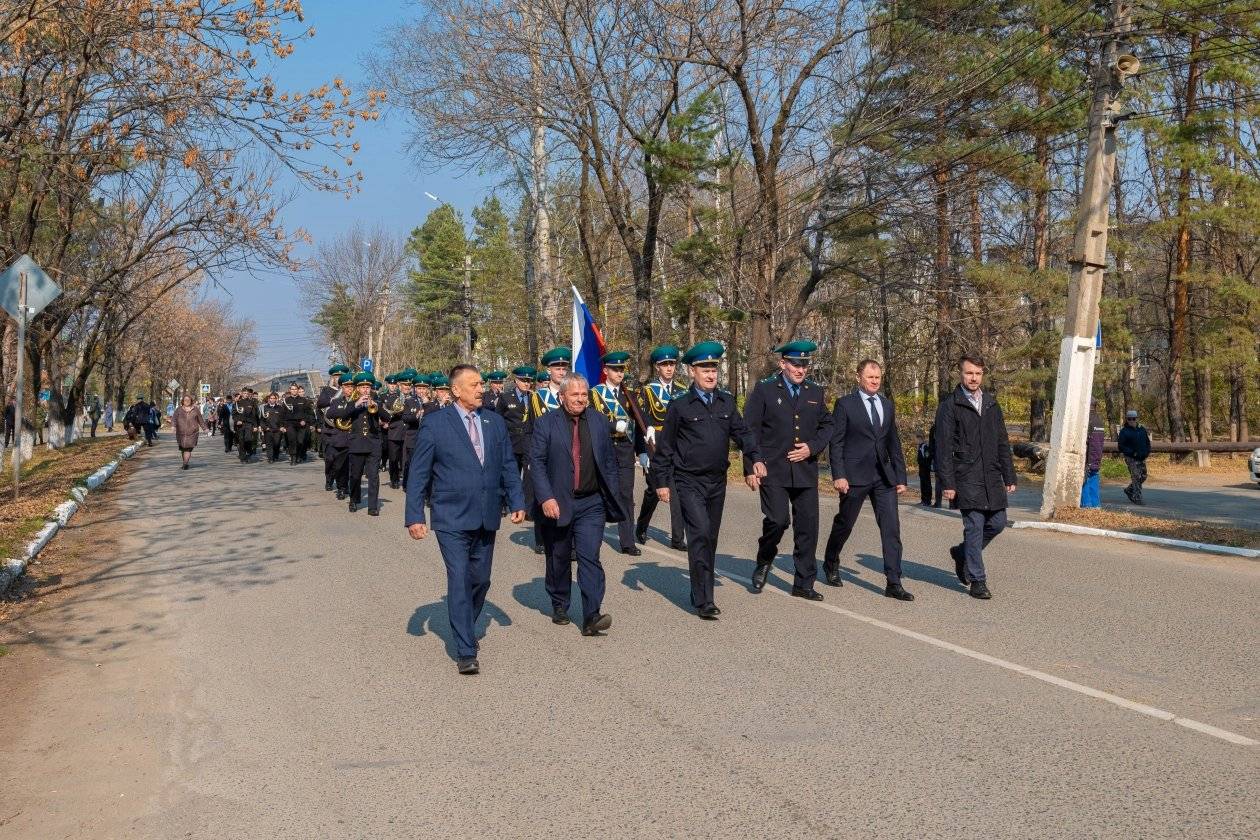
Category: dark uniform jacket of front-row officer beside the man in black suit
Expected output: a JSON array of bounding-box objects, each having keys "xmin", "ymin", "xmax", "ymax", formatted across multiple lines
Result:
[{"xmin": 743, "ymin": 373, "xmax": 833, "ymax": 487}]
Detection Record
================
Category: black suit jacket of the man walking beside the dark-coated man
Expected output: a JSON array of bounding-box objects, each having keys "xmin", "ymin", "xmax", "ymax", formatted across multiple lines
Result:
[{"xmin": 832, "ymin": 390, "xmax": 906, "ymax": 485}]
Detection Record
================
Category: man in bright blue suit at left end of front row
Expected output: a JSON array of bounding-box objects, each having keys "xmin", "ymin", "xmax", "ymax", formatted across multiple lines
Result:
[{"xmin": 404, "ymin": 364, "xmax": 525, "ymax": 674}]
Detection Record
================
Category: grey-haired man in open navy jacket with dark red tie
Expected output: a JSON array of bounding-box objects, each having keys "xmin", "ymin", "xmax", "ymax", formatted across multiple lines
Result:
[{"xmin": 529, "ymin": 373, "xmax": 626, "ymax": 636}]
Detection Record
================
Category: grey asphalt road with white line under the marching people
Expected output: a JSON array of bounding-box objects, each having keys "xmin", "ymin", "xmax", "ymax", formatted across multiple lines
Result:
[{"xmin": 0, "ymin": 436, "xmax": 1260, "ymax": 839}]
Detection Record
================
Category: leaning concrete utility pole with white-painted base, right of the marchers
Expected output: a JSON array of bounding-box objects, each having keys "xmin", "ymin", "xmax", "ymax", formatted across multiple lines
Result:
[{"xmin": 1041, "ymin": 0, "xmax": 1139, "ymax": 519}]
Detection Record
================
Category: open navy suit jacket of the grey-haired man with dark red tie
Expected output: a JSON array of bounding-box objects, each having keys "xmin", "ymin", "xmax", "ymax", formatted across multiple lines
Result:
[{"xmin": 529, "ymin": 407, "xmax": 627, "ymax": 526}]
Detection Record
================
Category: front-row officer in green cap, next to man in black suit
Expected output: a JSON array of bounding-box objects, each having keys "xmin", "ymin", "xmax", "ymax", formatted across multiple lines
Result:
[{"xmin": 743, "ymin": 341, "xmax": 832, "ymax": 601}]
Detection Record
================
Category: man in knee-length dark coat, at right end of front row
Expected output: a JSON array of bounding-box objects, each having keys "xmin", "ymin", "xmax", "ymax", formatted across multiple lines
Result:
[{"xmin": 936, "ymin": 354, "xmax": 1016, "ymax": 599}]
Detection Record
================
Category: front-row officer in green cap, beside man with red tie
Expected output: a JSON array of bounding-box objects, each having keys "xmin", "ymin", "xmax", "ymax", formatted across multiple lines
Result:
[{"xmin": 654, "ymin": 341, "xmax": 766, "ymax": 620}]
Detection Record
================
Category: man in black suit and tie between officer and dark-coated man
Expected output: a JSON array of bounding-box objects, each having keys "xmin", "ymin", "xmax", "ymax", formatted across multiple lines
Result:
[{"xmin": 823, "ymin": 359, "xmax": 915, "ymax": 601}]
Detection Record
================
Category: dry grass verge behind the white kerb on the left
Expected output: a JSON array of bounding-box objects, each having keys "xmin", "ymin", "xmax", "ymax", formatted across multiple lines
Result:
[{"xmin": 0, "ymin": 436, "xmax": 130, "ymax": 558}]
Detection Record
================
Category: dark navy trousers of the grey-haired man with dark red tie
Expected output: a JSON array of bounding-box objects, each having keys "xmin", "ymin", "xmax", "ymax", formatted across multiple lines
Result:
[{"xmin": 541, "ymin": 492, "xmax": 604, "ymax": 625}]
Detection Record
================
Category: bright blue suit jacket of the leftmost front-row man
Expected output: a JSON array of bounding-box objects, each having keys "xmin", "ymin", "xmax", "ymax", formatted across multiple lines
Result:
[{"xmin": 404, "ymin": 407, "xmax": 525, "ymax": 530}]
